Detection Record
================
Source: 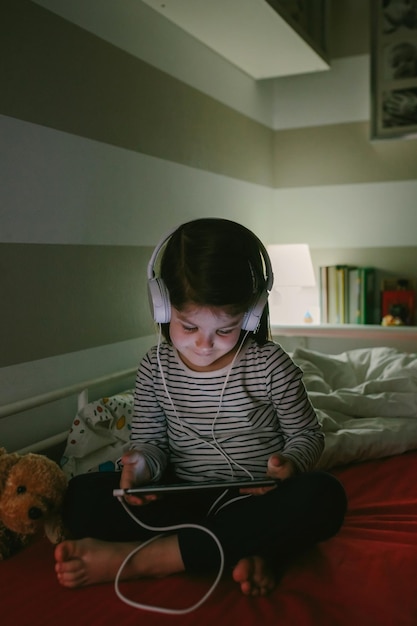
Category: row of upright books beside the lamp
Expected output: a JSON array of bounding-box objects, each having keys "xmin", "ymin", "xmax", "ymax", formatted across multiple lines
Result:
[{"xmin": 320, "ymin": 265, "xmax": 380, "ymax": 324}]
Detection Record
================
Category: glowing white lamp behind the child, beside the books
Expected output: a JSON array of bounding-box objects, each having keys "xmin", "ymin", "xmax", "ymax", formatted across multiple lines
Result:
[{"xmin": 267, "ymin": 243, "xmax": 320, "ymax": 325}]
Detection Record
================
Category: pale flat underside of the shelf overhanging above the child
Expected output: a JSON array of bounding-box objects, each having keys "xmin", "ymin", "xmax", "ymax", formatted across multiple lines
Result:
[{"xmin": 141, "ymin": 0, "xmax": 330, "ymax": 80}]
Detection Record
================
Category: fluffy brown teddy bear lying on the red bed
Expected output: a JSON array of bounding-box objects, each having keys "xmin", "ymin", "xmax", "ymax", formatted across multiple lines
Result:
[{"xmin": 0, "ymin": 448, "xmax": 67, "ymax": 561}]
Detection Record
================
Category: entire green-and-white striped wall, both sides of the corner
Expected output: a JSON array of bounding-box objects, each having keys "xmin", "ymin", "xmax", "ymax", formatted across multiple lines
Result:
[{"xmin": 0, "ymin": 0, "xmax": 417, "ymax": 449}]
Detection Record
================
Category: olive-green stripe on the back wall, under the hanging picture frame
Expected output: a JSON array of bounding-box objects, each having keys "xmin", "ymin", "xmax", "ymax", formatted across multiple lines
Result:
[{"xmin": 274, "ymin": 122, "xmax": 417, "ymax": 188}]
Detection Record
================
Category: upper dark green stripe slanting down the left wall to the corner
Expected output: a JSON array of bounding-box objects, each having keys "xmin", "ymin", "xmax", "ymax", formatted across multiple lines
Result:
[{"xmin": 0, "ymin": 0, "xmax": 272, "ymax": 185}]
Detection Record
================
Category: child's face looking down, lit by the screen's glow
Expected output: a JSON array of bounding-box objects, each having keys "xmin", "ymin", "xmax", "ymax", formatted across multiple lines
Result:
[{"xmin": 169, "ymin": 305, "xmax": 243, "ymax": 372}]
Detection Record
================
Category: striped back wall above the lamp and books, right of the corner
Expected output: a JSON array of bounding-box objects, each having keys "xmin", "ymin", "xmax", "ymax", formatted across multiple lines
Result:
[{"xmin": 270, "ymin": 0, "xmax": 417, "ymax": 258}]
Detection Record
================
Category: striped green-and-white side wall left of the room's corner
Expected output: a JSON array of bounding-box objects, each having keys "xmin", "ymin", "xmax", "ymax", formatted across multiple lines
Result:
[{"xmin": 0, "ymin": 0, "xmax": 273, "ymax": 450}]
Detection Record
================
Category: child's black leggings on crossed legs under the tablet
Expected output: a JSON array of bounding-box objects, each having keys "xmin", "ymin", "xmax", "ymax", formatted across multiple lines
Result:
[{"xmin": 64, "ymin": 471, "xmax": 347, "ymax": 572}]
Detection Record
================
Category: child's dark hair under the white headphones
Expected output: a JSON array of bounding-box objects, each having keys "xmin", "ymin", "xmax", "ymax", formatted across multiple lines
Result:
[{"xmin": 160, "ymin": 218, "xmax": 270, "ymax": 344}]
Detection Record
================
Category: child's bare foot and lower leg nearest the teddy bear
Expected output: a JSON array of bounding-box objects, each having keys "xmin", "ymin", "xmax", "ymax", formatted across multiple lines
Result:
[{"xmin": 55, "ymin": 535, "xmax": 184, "ymax": 588}]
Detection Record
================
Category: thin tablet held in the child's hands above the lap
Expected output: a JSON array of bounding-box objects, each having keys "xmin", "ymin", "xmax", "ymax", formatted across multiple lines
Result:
[{"xmin": 113, "ymin": 478, "xmax": 277, "ymax": 496}]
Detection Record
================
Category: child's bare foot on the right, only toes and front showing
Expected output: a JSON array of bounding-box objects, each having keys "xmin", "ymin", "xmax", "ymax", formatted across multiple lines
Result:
[{"xmin": 233, "ymin": 556, "xmax": 276, "ymax": 596}]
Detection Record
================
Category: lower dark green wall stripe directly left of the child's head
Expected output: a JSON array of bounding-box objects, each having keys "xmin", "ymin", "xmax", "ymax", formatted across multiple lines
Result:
[{"xmin": 0, "ymin": 244, "xmax": 154, "ymax": 367}]
